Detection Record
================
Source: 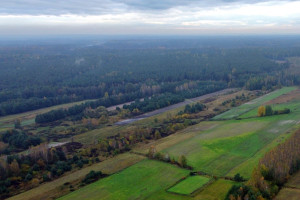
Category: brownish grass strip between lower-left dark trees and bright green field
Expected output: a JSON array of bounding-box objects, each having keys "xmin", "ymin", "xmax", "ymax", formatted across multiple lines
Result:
[{"xmin": 9, "ymin": 153, "xmax": 145, "ymax": 200}]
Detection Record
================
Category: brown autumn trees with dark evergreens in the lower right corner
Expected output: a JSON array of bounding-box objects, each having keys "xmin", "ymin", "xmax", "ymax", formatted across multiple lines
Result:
[{"xmin": 226, "ymin": 130, "xmax": 300, "ymax": 200}]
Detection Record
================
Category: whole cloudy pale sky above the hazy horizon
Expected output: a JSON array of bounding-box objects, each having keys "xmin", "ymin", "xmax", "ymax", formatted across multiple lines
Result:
[{"xmin": 0, "ymin": 0, "xmax": 300, "ymax": 35}]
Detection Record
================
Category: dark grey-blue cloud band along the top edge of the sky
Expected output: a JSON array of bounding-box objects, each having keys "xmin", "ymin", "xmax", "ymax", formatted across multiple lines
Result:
[{"xmin": 0, "ymin": 0, "xmax": 292, "ymax": 15}]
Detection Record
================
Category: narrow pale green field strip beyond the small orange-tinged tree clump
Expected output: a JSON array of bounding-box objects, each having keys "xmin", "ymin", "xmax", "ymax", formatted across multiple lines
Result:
[{"xmin": 213, "ymin": 87, "xmax": 297, "ymax": 120}]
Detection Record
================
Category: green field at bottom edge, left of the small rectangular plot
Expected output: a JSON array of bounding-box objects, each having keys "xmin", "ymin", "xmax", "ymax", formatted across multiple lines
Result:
[{"xmin": 60, "ymin": 160, "xmax": 188, "ymax": 200}]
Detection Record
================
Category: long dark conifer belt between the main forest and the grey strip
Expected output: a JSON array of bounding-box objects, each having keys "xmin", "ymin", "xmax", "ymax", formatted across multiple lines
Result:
[{"xmin": 35, "ymin": 82, "xmax": 225, "ymax": 123}]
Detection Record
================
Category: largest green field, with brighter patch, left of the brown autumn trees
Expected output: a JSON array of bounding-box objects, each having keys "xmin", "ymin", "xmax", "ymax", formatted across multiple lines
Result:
[{"xmin": 163, "ymin": 112, "xmax": 300, "ymax": 178}]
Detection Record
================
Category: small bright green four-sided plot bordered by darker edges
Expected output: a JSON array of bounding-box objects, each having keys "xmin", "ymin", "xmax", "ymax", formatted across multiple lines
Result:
[{"xmin": 168, "ymin": 176, "xmax": 211, "ymax": 195}]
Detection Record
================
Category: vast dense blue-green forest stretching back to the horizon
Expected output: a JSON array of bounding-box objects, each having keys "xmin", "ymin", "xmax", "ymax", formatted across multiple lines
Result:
[{"xmin": 0, "ymin": 36, "xmax": 300, "ymax": 116}]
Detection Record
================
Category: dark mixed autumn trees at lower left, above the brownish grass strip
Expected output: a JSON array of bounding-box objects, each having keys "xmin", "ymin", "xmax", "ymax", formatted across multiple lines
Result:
[{"xmin": 0, "ymin": 144, "xmax": 90, "ymax": 199}]
